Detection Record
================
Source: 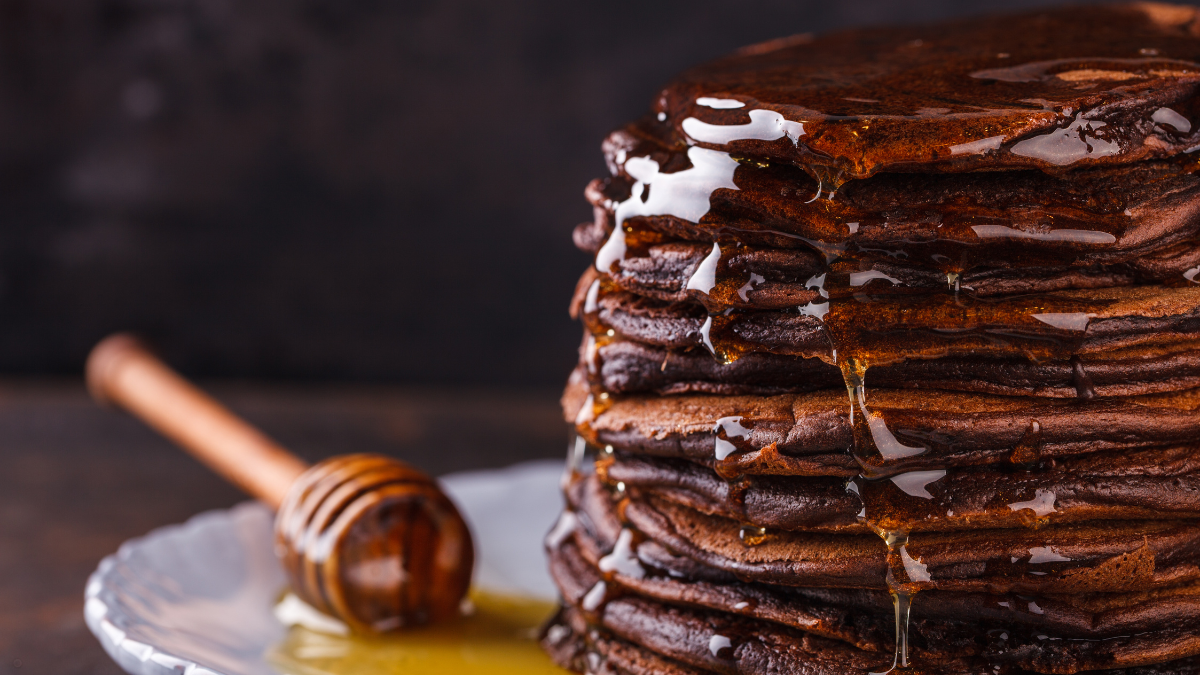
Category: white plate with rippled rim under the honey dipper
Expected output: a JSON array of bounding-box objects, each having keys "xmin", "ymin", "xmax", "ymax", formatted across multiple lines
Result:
[{"xmin": 84, "ymin": 461, "xmax": 563, "ymax": 675}]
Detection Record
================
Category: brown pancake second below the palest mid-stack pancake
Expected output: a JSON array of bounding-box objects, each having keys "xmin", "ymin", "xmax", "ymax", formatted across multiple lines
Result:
[{"xmin": 570, "ymin": 468, "xmax": 1200, "ymax": 595}]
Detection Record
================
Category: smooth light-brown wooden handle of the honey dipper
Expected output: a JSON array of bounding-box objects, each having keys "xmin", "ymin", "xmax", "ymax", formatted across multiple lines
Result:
[{"xmin": 88, "ymin": 333, "xmax": 307, "ymax": 509}]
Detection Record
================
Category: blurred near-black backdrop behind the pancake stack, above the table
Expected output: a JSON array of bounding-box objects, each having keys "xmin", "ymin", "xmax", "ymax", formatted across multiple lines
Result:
[{"xmin": 0, "ymin": 0, "xmax": 1142, "ymax": 386}]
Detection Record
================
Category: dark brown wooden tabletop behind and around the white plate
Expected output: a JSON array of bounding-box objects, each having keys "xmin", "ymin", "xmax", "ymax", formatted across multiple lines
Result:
[{"xmin": 0, "ymin": 381, "xmax": 566, "ymax": 675}]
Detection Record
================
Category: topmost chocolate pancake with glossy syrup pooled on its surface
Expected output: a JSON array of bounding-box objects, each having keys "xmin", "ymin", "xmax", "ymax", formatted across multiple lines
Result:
[{"xmin": 647, "ymin": 4, "xmax": 1200, "ymax": 180}]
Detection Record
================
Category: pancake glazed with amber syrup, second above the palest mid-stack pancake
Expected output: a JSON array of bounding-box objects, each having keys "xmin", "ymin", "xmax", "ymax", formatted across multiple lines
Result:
[{"xmin": 578, "ymin": 281, "xmax": 1200, "ymax": 363}]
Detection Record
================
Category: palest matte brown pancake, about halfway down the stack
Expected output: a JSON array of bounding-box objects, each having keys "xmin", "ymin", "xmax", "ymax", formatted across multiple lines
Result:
[{"xmin": 564, "ymin": 369, "xmax": 1200, "ymax": 478}]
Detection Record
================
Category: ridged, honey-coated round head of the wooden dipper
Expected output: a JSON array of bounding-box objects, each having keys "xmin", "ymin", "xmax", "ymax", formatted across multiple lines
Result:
[{"xmin": 276, "ymin": 454, "xmax": 474, "ymax": 634}]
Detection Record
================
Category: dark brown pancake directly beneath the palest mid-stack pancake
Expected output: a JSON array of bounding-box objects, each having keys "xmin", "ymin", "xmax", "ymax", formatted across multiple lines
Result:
[{"xmin": 602, "ymin": 448, "xmax": 1200, "ymax": 533}]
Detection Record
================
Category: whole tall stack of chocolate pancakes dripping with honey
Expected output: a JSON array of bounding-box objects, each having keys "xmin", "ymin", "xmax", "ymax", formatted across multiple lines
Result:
[{"xmin": 544, "ymin": 5, "xmax": 1200, "ymax": 675}]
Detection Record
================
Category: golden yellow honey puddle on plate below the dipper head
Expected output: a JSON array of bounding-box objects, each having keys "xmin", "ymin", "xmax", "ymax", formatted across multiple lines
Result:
[{"xmin": 266, "ymin": 590, "xmax": 564, "ymax": 675}]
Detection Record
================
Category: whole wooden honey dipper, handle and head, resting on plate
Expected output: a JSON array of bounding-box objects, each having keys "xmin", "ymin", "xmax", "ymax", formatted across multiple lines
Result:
[{"xmin": 88, "ymin": 334, "xmax": 475, "ymax": 633}]
